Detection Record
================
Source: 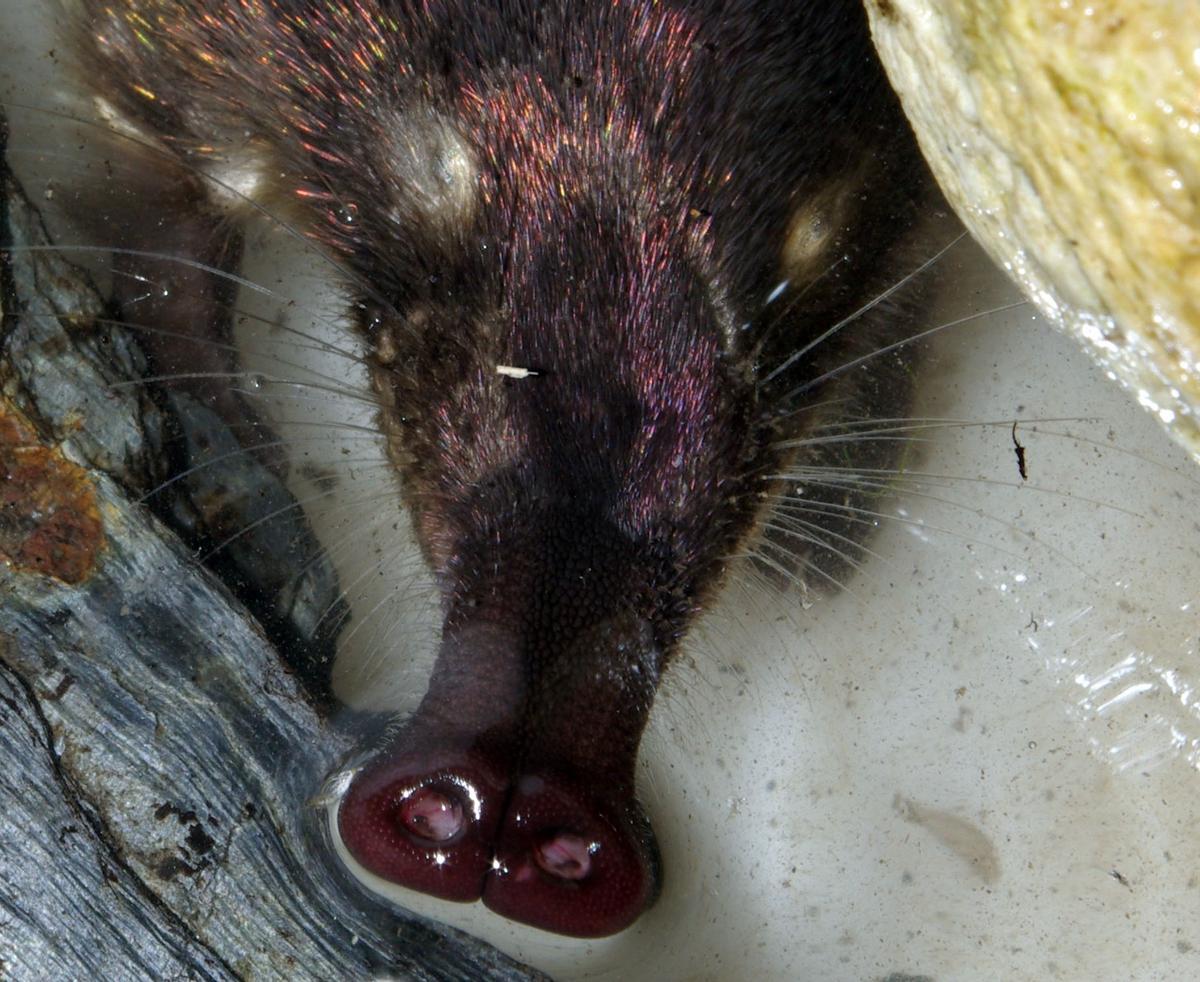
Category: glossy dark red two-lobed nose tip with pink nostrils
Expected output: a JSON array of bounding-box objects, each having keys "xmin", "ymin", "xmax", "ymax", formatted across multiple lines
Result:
[{"xmin": 337, "ymin": 749, "xmax": 659, "ymax": 938}]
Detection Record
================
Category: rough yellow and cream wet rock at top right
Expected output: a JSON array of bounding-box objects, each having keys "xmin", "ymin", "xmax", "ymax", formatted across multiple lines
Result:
[{"xmin": 866, "ymin": 0, "xmax": 1200, "ymax": 455}]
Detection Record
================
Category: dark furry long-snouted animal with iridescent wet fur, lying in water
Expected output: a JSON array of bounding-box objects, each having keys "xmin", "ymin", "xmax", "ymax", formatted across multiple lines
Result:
[{"xmin": 65, "ymin": 0, "xmax": 934, "ymax": 935}]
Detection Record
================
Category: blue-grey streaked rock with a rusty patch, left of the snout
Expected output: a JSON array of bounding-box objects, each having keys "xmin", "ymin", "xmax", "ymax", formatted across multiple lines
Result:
[{"xmin": 0, "ymin": 111, "xmax": 544, "ymax": 980}]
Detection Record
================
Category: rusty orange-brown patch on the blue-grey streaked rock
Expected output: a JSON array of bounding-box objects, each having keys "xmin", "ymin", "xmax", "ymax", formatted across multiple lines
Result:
[{"xmin": 0, "ymin": 401, "xmax": 104, "ymax": 585}]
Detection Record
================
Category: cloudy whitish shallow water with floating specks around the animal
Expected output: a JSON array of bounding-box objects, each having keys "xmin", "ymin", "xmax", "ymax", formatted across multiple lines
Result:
[{"xmin": 0, "ymin": 0, "xmax": 1200, "ymax": 980}]
